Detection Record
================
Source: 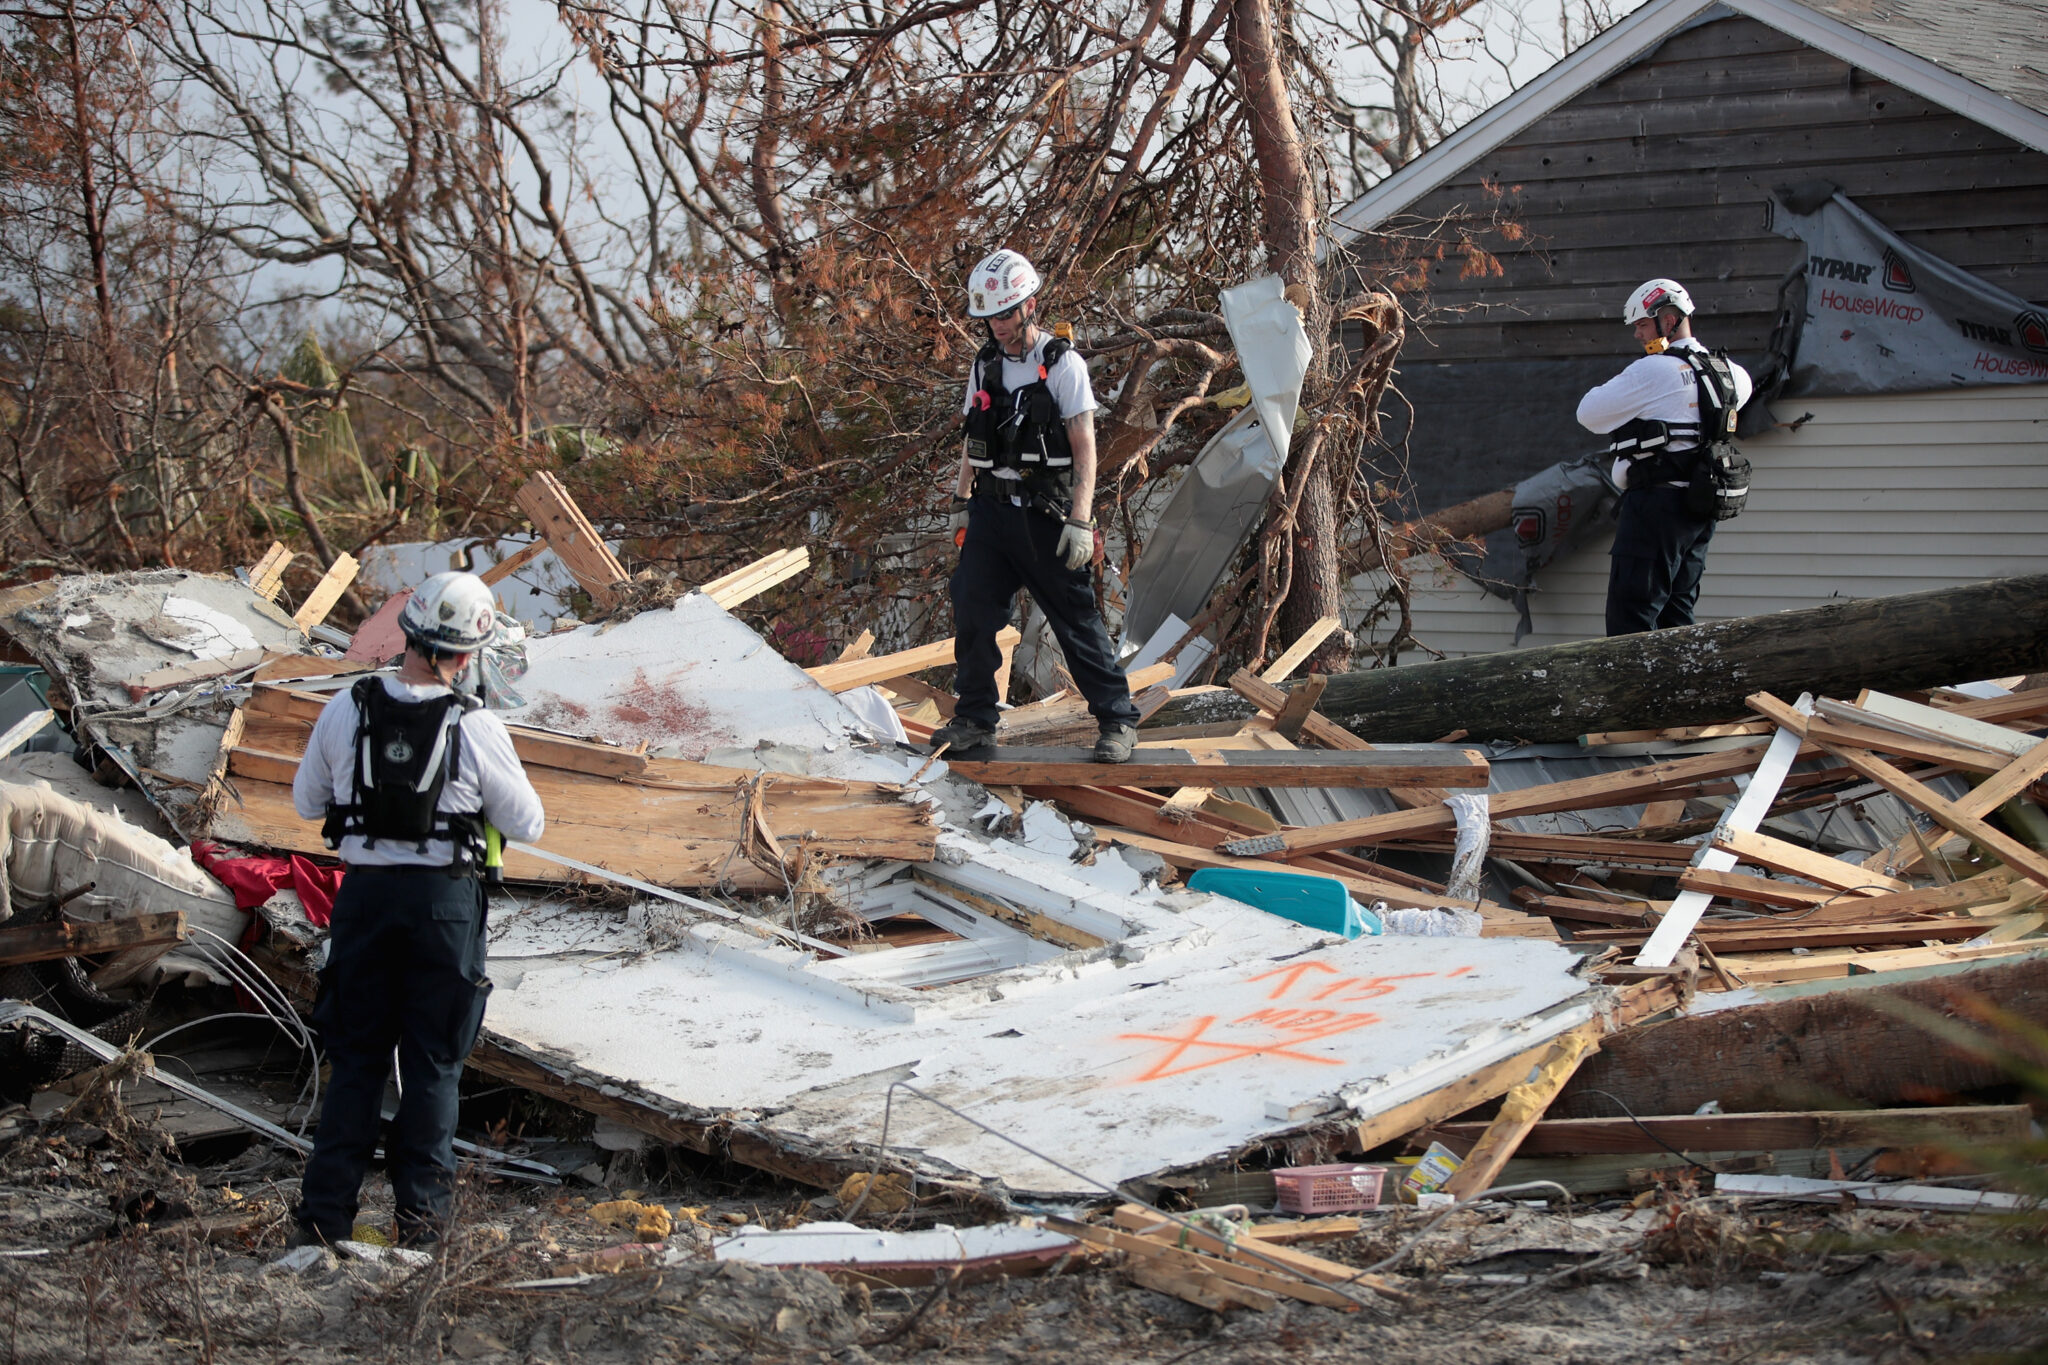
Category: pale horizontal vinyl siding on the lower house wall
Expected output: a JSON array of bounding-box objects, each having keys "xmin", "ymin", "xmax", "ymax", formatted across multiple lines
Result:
[{"xmin": 1352, "ymin": 385, "xmax": 2048, "ymax": 663}]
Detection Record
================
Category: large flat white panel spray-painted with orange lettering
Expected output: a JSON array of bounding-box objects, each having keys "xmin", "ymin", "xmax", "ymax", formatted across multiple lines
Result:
[{"xmin": 489, "ymin": 835, "xmax": 1602, "ymax": 1199}]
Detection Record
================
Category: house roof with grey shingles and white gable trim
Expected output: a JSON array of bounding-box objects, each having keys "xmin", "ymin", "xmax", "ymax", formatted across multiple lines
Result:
[{"xmin": 1331, "ymin": 0, "xmax": 2048, "ymax": 237}]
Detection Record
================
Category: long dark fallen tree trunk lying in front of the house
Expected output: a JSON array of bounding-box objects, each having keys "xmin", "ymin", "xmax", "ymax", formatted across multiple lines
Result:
[{"xmin": 1153, "ymin": 575, "xmax": 2048, "ymax": 743}]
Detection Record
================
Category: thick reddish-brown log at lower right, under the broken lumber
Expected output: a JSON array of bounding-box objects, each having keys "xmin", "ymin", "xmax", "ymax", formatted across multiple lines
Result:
[{"xmin": 1548, "ymin": 958, "xmax": 2048, "ymax": 1117}]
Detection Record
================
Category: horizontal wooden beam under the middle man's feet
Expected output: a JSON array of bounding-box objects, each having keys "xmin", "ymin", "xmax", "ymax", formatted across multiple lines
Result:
[{"xmin": 948, "ymin": 749, "xmax": 1487, "ymax": 788}]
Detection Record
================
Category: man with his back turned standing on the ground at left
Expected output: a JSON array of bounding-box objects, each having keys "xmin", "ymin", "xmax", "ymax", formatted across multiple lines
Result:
[{"xmin": 291, "ymin": 573, "xmax": 545, "ymax": 1246}]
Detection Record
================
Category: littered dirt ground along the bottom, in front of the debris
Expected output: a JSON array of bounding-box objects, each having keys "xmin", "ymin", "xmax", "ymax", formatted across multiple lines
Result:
[{"xmin": 0, "ymin": 1105, "xmax": 2048, "ymax": 1365}]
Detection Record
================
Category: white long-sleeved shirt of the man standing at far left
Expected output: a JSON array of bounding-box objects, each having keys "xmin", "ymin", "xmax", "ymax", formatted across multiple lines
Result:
[{"xmin": 291, "ymin": 675, "xmax": 547, "ymax": 868}]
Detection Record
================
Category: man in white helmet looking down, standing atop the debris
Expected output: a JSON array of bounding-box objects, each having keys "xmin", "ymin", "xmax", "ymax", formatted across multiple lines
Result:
[{"xmin": 932, "ymin": 252, "xmax": 1139, "ymax": 763}]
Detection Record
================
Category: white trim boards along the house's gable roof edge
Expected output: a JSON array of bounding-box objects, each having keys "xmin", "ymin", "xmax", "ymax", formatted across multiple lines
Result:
[{"xmin": 1329, "ymin": 0, "xmax": 2048, "ymax": 237}]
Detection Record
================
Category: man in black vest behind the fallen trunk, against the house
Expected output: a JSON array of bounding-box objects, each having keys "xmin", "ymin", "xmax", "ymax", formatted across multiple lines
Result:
[{"xmin": 1579, "ymin": 280, "xmax": 1751, "ymax": 634}]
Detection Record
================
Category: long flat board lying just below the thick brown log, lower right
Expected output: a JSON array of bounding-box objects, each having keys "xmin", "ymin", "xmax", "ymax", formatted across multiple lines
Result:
[{"xmin": 1430, "ymin": 1105, "xmax": 2034, "ymax": 1156}]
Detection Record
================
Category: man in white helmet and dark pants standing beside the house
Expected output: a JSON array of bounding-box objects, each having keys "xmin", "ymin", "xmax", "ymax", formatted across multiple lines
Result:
[{"xmin": 1579, "ymin": 280, "xmax": 1751, "ymax": 634}]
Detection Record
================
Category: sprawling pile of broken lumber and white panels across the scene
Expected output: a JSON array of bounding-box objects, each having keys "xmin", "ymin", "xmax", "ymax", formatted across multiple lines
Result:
[{"xmin": 0, "ymin": 475, "xmax": 2048, "ymax": 1342}]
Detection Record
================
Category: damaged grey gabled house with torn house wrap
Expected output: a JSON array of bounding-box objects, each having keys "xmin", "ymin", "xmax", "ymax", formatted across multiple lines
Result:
[{"xmin": 1335, "ymin": 0, "xmax": 2048, "ymax": 655}]
